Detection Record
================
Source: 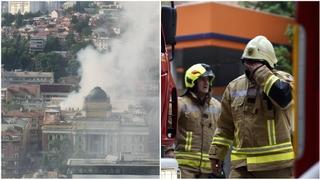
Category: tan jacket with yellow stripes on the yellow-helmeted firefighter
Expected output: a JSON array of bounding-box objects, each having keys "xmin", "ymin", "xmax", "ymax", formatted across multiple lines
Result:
[{"xmin": 175, "ymin": 91, "xmax": 220, "ymax": 173}]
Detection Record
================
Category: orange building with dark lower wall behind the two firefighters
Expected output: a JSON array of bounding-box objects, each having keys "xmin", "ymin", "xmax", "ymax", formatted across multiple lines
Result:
[{"xmin": 175, "ymin": 2, "xmax": 296, "ymax": 98}]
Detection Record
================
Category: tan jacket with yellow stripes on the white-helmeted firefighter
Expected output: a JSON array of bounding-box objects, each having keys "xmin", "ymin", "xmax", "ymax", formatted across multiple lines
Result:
[{"xmin": 209, "ymin": 65, "xmax": 294, "ymax": 171}]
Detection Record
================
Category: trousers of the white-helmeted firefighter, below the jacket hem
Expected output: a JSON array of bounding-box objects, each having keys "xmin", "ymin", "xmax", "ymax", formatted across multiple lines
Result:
[{"xmin": 229, "ymin": 166, "xmax": 293, "ymax": 179}]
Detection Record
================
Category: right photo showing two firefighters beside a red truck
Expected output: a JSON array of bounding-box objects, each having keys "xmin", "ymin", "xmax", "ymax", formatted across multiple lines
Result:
[{"xmin": 160, "ymin": 1, "xmax": 320, "ymax": 179}]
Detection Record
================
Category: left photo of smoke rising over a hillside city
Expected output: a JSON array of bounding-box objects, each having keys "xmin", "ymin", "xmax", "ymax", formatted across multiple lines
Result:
[{"xmin": 1, "ymin": 1, "xmax": 160, "ymax": 179}]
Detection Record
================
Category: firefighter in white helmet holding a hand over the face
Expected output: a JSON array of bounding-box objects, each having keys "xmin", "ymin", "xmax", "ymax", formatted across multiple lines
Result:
[{"xmin": 209, "ymin": 36, "xmax": 294, "ymax": 178}]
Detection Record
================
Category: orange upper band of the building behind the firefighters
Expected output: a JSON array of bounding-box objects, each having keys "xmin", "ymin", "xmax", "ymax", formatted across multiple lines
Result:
[{"xmin": 176, "ymin": 2, "xmax": 296, "ymax": 50}]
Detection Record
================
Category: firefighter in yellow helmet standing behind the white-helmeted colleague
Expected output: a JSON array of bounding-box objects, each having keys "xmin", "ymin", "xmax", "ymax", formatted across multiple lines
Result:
[{"xmin": 171, "ymin": 63, "xmax": 220, "ymax": 178}]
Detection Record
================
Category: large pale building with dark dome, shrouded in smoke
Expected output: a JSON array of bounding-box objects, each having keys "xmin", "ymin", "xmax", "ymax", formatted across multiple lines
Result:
[{"xmin": 42, "ymin": 87, "xmax": 151, "ymax": 160}]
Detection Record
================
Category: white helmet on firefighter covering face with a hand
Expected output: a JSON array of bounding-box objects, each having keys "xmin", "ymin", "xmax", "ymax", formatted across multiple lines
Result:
[{"xmin": 241, "ymin": 36, "xmax": 278, "ymax": 68}]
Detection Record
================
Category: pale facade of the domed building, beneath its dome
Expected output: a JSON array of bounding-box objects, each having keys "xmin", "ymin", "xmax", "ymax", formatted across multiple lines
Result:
[{"xmin": 42, "ymin": 121, "xmax": 149, "ymax": 158}]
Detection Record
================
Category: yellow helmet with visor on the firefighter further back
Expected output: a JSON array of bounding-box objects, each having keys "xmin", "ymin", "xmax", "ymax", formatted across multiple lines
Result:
[{"xmin": 184, "ymin": 63, "xmax": 215, "ymax": 88}]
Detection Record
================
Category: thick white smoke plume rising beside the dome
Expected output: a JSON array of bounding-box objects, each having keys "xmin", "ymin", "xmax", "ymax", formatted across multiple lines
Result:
[{"xmin": 60, "ymin": 2, "xmax": 160, "ymax": 109}]
